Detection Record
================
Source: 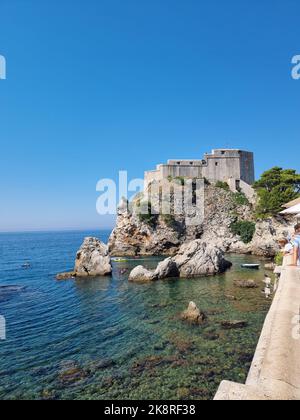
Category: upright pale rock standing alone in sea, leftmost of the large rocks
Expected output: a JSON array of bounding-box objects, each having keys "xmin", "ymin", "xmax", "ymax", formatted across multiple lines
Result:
[{"xmin": 74, "ymin": 238, "xmax": 112, "ymax": 277}]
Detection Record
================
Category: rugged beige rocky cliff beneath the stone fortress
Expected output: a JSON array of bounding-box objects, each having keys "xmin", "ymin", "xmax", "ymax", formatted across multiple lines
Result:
[{"xmin": 109, "ymin": 185, "xmax": 292, "ymax": 257}]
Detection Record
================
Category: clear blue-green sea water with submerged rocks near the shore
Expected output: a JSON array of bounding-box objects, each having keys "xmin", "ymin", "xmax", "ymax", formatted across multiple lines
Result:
[{"xmin": 0, "ymin": 232, "xmax": 270, "ymax": 400}]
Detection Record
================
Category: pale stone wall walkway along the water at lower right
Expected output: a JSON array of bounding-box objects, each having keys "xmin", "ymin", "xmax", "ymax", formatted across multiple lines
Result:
[{"xmin": 215, "ymin": 264, "xmax": 300, "ymax": 400}]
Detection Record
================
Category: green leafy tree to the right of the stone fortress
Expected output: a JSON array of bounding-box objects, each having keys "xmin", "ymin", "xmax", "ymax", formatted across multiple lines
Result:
[{"xmin": 254, "ymin": 166, "xmax": 300, "ymax": 218}]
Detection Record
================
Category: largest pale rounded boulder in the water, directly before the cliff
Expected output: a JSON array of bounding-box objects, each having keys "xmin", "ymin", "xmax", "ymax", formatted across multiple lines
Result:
[{"xmin": 173, "ymin": 240, "xmax": 232, "ymax": 278}]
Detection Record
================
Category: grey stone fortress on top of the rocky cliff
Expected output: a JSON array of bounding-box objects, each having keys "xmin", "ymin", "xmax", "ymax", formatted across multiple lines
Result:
[{"xmin": 145, "ymin": 149, "xmax": 255, "ymax": 198}]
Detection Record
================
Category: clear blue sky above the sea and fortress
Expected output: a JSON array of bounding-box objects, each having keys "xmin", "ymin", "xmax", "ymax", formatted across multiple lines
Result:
[{"xmin": 0, "ymin": 0, "xmax": 300, "ymax": 231}]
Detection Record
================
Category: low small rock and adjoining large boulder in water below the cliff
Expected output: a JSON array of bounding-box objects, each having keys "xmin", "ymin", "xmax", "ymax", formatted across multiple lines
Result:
[{"xmin": 129, "ymin": 239, "xmax": 232, "ymax": 282}]
